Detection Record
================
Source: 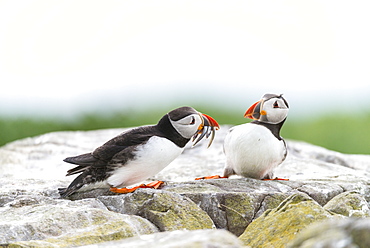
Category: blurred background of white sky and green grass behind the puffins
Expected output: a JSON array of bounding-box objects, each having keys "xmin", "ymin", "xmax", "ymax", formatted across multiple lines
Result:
[{"xmin": 0, "ymin": 0, "xmax": 370, "ymax": 154}]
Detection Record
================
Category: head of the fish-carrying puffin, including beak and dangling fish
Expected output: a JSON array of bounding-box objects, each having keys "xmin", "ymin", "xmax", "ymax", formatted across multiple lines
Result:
[{"xmin": 168, "ymin": 107, "xmax": 220, "ymax": 145}]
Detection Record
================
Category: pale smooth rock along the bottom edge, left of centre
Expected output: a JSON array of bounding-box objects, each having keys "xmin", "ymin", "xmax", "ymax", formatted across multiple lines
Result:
[{"xmin": 80, "ymin": 230, "xmax": 243, "ymax": 248}]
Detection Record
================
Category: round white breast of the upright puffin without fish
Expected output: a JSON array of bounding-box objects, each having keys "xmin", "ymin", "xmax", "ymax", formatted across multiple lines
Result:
[{"xmin": 224, "ymin": 123, "xmax": 286, "ymax": 179}]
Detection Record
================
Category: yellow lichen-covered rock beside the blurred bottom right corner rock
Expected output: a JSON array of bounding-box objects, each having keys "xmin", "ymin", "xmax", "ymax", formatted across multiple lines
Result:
[{"xmin": 239, "ymin": 193, "xmax": 340, "ymax": 248}]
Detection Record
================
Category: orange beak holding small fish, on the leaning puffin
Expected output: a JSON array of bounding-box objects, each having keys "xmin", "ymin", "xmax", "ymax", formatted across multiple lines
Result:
[{"xmin": 193, "ymin": 113, "xmax": 220, "ymax": 148}]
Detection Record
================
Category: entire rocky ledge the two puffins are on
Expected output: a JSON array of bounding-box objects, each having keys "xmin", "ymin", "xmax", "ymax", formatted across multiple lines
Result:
[{"xmin": 0, "ymin": 126, "xmax": 370, "ymax": 247}]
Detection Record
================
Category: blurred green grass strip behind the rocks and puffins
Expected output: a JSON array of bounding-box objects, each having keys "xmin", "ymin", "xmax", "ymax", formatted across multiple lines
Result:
[{"xmin": 0, "ymin": 107, "xmax": 370, "ymax": 154}]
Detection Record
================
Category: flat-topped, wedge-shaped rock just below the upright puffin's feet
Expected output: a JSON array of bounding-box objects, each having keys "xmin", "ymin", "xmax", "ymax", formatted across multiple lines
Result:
[{"xmin": 163, "ymin": 178, "xmax": 292, "ymax": 236}]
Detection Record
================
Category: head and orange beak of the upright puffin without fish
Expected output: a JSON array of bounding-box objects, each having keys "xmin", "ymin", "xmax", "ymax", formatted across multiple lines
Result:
[{"xmin": 244, "ymin": 94, "xmax": 289, "ymax": 124}]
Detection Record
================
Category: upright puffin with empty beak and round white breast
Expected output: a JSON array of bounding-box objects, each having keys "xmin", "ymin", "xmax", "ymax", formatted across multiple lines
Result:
[{"xmin": 196, "ymin": 93, "xmax": 289, "ymax": 180}]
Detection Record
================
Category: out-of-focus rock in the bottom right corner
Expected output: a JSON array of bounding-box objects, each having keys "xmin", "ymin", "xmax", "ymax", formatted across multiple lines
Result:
[{"xmin": 287, "ymin": 218, "xmax": 370, "ymax": 248}]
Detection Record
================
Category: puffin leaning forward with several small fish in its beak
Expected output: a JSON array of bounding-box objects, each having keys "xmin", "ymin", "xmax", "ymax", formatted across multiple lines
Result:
[{"xmin": 58, "ymin": 106, "xmax": 220, "ymax": 198}]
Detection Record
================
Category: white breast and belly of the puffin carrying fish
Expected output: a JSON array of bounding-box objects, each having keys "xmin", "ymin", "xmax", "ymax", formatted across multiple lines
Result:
[{"xmin": 107, "ymin": 136, "xmax": 184, "ymax": 187}]
